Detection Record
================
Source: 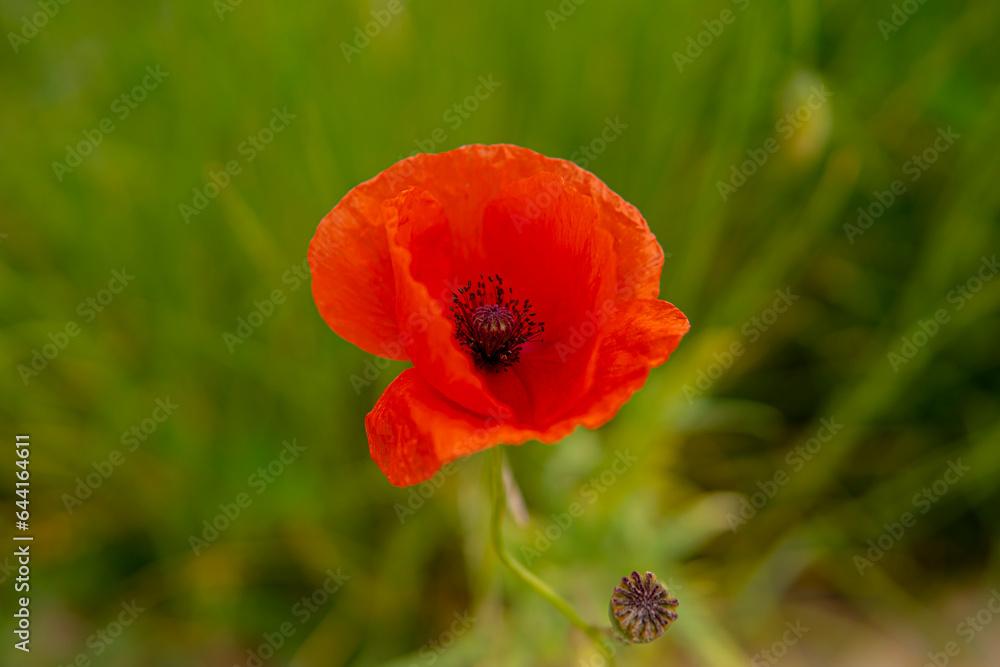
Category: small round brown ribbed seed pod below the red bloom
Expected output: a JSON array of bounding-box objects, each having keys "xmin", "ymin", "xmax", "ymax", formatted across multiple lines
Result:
[{"xmin": 608, "ymin": 572, "xmax": 678, "ymax": 644}]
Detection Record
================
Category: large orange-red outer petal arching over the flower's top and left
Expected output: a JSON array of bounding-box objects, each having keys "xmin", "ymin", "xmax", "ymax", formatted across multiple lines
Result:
[{"xmin": 309, "ymin": 144, "xmax": 663, "ymax": 359}]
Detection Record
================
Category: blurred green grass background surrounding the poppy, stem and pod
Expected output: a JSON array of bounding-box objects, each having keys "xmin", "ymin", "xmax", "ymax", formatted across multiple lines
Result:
[{"xmin": 0, "ymin": 0, "xmax": 1000, "ymax": 667}]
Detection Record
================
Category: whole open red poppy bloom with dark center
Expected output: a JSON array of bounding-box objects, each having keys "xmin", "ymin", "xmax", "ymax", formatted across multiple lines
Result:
[{"xmin": 309, "ymin": 145, "xmax": 689, "ymax": 486}]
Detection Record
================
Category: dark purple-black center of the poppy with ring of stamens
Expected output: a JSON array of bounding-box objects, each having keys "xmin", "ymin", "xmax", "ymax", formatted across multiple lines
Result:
[{"xmin": 450, "ymin": 275, "xmax": 545, "ymax": 372}]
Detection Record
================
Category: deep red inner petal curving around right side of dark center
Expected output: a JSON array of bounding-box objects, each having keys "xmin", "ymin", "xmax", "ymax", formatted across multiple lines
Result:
[{"xmin": 482, "ymin": 172, "xmax": 617, "ymax": 426}]
